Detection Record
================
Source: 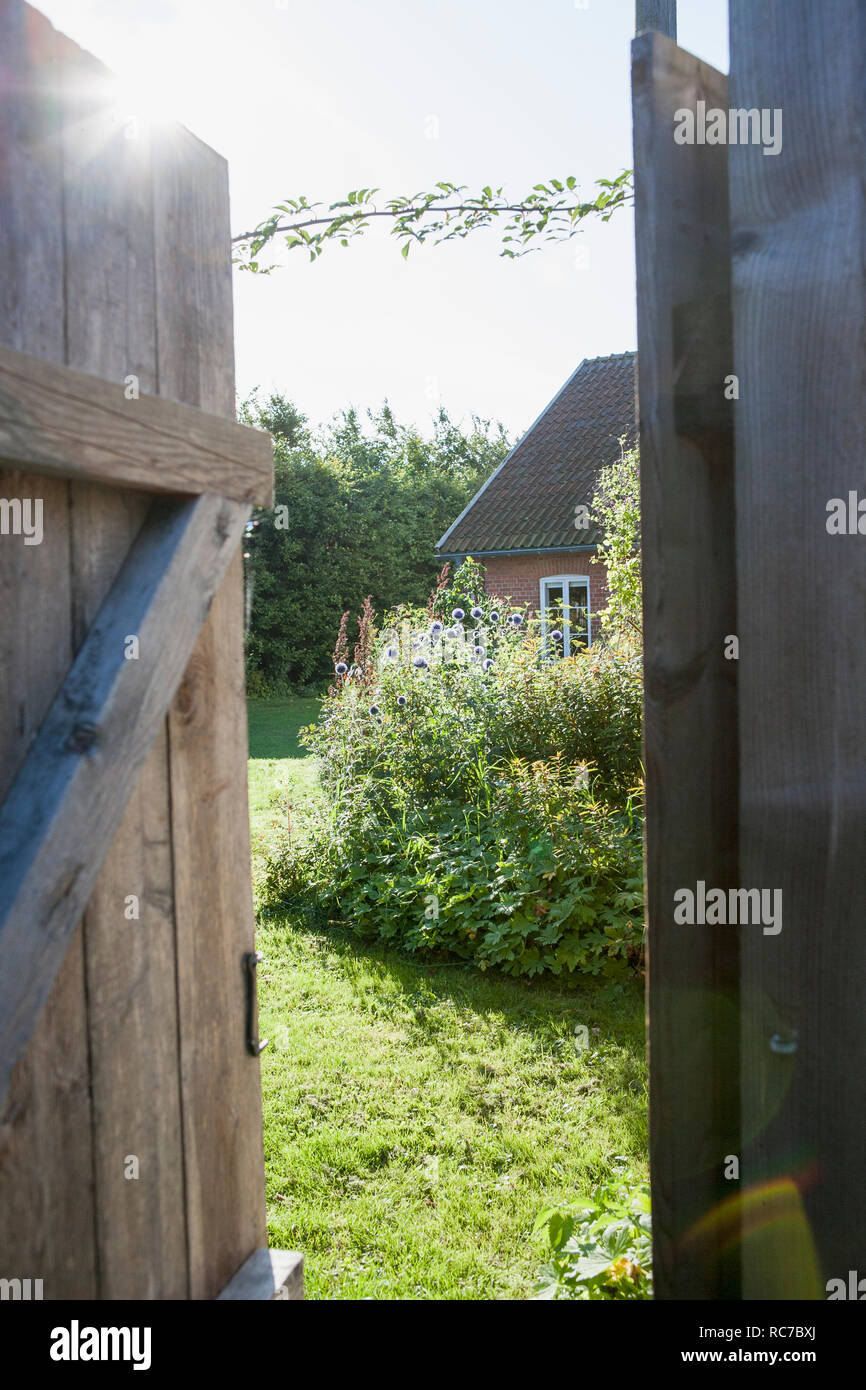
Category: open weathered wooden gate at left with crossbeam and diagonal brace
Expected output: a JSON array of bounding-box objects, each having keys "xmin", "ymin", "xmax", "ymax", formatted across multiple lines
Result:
[{"xmin": 0, "ymin": 0, "xmax": 294, "ymax": 1298}]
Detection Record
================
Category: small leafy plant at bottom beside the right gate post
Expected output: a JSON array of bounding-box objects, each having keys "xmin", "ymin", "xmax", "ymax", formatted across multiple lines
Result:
[{"xmin": 534, "ymin": 1168, "xmax": 652, "ymax": 1301}]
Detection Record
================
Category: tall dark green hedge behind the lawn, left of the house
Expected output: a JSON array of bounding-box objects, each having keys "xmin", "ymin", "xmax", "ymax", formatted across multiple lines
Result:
[{"xmin": 240, "ymin": 393, "xmax": 509, "ymax": 695}]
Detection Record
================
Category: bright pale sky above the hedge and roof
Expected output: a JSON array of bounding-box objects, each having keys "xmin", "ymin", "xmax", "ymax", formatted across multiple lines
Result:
[{"xmin": 36, "ymin": 0, "xmax": 728, "ymax": 434}]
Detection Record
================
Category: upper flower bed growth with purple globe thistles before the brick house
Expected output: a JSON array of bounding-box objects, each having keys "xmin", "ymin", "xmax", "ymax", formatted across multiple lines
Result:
[{"xmin": 307, "ymin": 563, "xmax": 642, "ymax": 809}]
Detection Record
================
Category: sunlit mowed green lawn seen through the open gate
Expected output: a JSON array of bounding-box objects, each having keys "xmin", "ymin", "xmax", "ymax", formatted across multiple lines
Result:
[{"xmin": 249, "ymin": 699, "xmax": 646, "ymax": 1300}]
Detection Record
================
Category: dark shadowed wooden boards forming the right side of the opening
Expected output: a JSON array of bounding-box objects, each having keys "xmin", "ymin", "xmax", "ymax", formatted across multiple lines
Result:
[{"xmin": 632, "ymin": 0, "xmax": 866, "ymax": 1300}]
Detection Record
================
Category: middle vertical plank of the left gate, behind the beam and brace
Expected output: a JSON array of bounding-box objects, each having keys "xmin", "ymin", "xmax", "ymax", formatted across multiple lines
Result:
[{"xmin": 61, "ymin": 43, "xmax": 189, "ymax": 1298}]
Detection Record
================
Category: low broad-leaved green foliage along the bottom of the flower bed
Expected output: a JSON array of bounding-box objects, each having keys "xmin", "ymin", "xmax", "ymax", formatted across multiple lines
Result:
[{"xmin": 276, "ymin": 760, "xmax": 642, "ymax": 979}]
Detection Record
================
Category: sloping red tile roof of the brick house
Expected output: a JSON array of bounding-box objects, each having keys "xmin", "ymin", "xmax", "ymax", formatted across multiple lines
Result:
[{"xmin": 436, "ymin": 352, "xmax": 637, "ymax": 556}]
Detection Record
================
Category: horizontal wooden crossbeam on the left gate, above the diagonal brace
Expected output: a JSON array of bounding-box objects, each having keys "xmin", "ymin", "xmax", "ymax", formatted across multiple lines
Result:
[{"xmin": 0, "ymin": 346, "xmax": 274, "ymax": 506}]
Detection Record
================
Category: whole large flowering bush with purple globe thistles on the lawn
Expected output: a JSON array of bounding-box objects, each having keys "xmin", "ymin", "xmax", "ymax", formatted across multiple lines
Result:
[{"xmin": 261, "ymin": 567, "xmax": 642, "ymax": 979}]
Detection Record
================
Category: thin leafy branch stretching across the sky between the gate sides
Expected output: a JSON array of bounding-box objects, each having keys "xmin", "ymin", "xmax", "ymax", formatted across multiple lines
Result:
[{"xmin": 232, "ymin": 170, "xmax": 634, "ymax": 275}]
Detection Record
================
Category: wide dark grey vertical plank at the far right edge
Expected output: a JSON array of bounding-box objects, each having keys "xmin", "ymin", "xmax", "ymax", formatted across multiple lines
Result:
[{"xmin": 730, "ymin": 0, "xmax": 866, "ymax": 1298}]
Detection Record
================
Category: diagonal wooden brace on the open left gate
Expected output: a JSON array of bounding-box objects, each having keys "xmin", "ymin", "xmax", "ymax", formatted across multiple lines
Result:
[{"xmin": 0, "ymin": 496, "xmax": 249, "ymax": 1104}]
